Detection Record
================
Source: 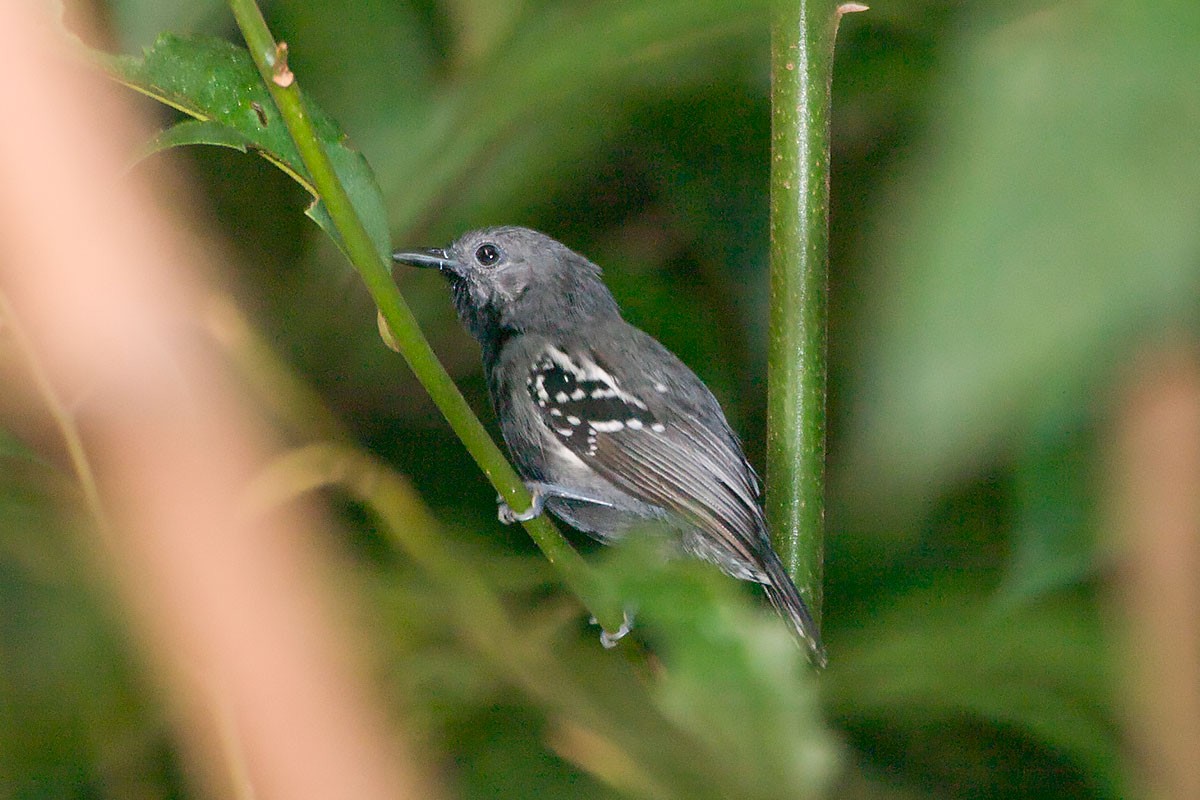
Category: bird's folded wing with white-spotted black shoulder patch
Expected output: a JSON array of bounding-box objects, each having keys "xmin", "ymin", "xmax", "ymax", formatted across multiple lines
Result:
[{"xmin": 526, "ymin": 343, "xmax": 766, "ymax": 565}]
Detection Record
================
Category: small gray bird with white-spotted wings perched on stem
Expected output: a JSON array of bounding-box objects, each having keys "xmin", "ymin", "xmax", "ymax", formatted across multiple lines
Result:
[{"xmin": 394, "ymin": 227, "xmax": 826, "ymax": 666}]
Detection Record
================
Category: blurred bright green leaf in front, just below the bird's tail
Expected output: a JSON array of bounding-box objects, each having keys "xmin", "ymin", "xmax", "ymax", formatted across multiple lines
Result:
[{"xmin": 595, "ymin": 542, "xmax": 838, "ymax": 798}]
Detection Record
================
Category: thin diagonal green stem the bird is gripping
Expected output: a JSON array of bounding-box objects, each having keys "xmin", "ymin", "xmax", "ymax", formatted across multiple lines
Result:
[{"xmin": 229, "ymin": 0, "xmax": 623, "ymax": 631}]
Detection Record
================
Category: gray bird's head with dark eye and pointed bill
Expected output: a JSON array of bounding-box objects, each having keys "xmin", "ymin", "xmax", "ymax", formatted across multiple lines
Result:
[{"xmin": 392, "ymin": 227, "xmax": 619, "ymax": 344}]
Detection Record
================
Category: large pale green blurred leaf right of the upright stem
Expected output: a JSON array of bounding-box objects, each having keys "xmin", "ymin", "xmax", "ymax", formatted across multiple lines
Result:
[{"xmin": 846, "ymin": 0, "xmax": 1200, "ymax": 510}]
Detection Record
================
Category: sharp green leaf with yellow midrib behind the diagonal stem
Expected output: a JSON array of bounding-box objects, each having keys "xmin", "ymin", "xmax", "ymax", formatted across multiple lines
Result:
[{"xmin": 101, "ymin": 35, "xmax": 391, "ymax": 260}]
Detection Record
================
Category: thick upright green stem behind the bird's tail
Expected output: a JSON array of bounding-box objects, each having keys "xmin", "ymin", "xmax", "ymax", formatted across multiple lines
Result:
[{"xmin": 767, "ymin": 0, "xmax": 862, "ymax": 638}]
